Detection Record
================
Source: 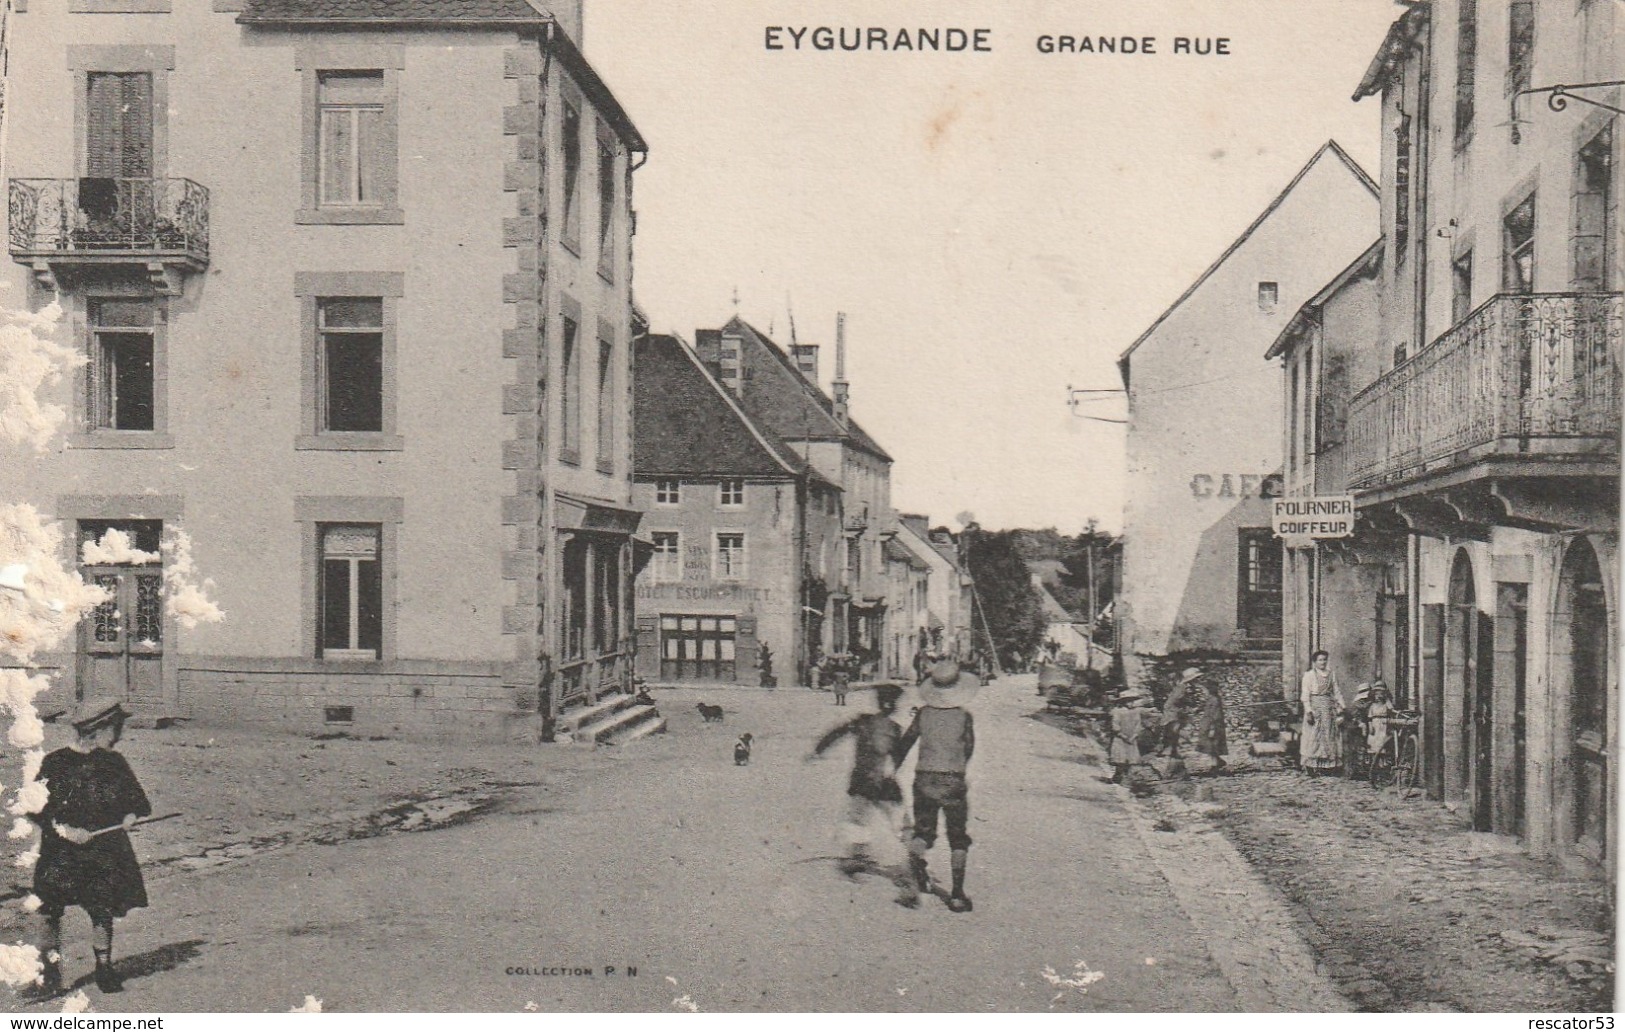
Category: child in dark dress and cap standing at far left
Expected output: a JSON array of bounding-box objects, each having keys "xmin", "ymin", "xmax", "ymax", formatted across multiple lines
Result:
[{"xmin": 33, "ymin": 697, "xmax": 153, "ymax": 995}]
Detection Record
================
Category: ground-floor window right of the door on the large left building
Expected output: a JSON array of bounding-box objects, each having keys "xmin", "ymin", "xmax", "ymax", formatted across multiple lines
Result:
[{"xmin": 317, "ymin": 523, "xmax": 384, "ymax": 660}]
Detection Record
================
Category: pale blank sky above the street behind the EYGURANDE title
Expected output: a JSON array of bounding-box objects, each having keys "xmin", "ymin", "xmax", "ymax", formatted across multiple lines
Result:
[{"xmin": 585, "ymin": 0, "xmax": 1401, "ymax": 533}]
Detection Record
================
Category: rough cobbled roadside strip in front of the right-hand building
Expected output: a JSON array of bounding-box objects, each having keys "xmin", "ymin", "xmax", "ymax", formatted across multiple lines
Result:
[{"xmin": 1051, "ymin": 705, "xmax": 1614, "ymax": 1012}]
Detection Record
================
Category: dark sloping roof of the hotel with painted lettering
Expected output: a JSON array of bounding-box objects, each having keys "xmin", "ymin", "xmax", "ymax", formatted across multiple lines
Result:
[{"xmin": 632, "ymin": 333, "xmax": 827, "ymax": 484}]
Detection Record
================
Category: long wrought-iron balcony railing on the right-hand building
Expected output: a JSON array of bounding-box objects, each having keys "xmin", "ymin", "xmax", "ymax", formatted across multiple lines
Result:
[{"xmin": 1347, "ymin": 293, "xmax": 1625, "ymax": 489}]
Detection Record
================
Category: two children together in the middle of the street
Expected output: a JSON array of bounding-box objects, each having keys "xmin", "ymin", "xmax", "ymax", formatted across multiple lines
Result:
[{"xmin": 808, "ymin": 660, "xmax": 982, "ymax": 913}]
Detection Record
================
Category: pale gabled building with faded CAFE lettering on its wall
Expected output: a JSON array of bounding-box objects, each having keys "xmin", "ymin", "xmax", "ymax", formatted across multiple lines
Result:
[{"xmin": 1113, "ymin": 141, "xmax": 1378, "ymax": 694}]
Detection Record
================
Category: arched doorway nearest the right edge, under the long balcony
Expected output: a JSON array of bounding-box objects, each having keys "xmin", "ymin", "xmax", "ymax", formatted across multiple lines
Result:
[{"xmin": 1554, "ymin": 538, "xmax": 1610, "ymax": 863}]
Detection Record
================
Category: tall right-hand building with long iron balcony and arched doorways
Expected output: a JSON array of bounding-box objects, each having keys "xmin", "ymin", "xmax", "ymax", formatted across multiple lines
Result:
[{"xmin": 1341, "ymin": 0, "xmax": 1625, "ymax": 873}]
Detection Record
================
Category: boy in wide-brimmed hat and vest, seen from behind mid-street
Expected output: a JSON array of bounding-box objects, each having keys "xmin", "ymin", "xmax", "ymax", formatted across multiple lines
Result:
[{"xmin": 897, "ymin": 660, "xmax": 982, "ymax": 913}]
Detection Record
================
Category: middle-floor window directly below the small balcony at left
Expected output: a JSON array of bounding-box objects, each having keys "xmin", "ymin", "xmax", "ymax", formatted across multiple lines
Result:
[{"xmin": 88, "ymin": 299, "xmax": 158, "ymax": 431}]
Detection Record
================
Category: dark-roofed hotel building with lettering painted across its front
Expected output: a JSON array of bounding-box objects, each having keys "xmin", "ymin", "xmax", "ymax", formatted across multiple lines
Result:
[{"xmin": 632, "ymin": 335, "xmax": 842, "ymax": 684}]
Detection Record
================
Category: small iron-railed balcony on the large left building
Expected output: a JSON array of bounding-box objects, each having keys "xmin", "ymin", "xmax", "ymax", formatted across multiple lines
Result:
[{"xmin": 7, "ymin": 177, "xmax": 208, "ymax": 293}]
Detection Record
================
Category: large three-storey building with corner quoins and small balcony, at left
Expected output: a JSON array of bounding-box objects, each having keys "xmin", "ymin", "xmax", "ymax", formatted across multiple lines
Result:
[{"xmin": 0, "ymin": 0, "xmax": 647, "ymax": 736}]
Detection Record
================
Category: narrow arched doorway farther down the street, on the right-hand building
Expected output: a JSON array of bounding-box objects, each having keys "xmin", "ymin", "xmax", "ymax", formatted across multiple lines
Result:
[{"xmin": 1445, "ymin": 548, "xmax": 1495, "ymax": 830}]
